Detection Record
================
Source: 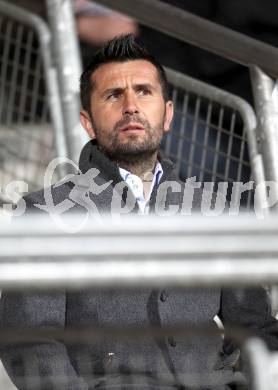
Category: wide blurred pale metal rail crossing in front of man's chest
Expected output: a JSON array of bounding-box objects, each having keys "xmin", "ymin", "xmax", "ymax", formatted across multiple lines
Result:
[{"xmin": 0, "ymin": 216, "xmax": 278, "ymax": 289}]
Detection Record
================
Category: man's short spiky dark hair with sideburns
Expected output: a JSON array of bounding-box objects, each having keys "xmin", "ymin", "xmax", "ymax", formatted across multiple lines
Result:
[{"xmin": 80, "ymin": 34, "xmax": 169, "ymax": 112}]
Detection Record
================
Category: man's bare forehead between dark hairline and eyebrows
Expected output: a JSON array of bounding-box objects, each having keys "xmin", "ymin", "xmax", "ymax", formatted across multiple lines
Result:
[{"xmin": 91, "ymin": 60, "xmax": 160, "ymax": 90}]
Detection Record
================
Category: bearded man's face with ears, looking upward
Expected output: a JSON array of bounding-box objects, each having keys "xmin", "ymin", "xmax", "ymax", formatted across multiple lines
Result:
[{"xmin": 81, "ymin": 60, "xmax": 173, "ymax": 157}]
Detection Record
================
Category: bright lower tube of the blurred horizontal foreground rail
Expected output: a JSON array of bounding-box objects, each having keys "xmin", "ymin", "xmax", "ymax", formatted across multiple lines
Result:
[{"xmin": 0, "ymin": 256, "xmax": 278, "ymax": 290}]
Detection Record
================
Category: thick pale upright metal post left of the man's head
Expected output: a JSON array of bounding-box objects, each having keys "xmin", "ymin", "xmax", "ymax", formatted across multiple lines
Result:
[{"xmin": 46, "ymin": 0, "xmax": 88, "ymax": 162}]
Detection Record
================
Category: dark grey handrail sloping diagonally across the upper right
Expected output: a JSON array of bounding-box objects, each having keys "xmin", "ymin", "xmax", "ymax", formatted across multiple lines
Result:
[{"xmin": 96, "ymin": 0, "xmax": 278, "ymax": 77}]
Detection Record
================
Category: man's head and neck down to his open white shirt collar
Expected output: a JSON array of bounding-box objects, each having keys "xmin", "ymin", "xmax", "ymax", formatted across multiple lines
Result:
[{"xmin": 77, "ymin": 31, "xmax": 173, "ymax": 215}]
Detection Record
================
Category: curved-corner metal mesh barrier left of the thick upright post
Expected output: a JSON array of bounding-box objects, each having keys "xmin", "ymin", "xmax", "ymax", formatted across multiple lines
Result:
[{"xmin": 0, "ymin": 1, "xmax": 68, "ymax": 198}]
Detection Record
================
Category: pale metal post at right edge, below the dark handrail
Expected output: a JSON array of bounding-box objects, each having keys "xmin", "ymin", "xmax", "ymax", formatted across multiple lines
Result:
[{"xmin": 250, "ymin": 66, "xmax": 278, "ymax": 210}]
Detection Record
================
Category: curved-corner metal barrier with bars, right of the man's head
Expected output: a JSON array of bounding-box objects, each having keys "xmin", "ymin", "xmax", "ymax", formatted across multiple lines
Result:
[{"xmin": 162, "ymin": 69, "xmax": 266, "ymax": 208}]
